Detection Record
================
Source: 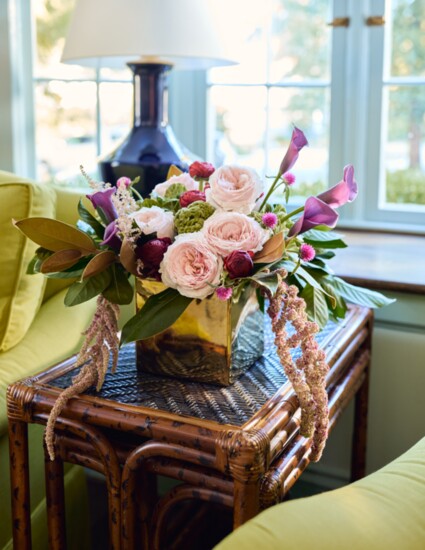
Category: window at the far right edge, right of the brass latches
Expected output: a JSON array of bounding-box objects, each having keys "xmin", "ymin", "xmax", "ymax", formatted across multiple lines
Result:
[{"xmin": 367, "ymin": 0, "xmax": 425, "ymax": 224}]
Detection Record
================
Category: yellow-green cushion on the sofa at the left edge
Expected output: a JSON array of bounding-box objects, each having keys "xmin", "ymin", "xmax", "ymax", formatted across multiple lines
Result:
[{"xmin": 0, "ymin": 172, "xmax": 56, "ymax": 351}]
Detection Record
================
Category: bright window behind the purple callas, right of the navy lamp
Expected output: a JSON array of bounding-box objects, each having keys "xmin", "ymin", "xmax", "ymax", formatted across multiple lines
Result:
[{"xmin": 208, "ymin": 0, "xmax": 332, "ymax": 203}]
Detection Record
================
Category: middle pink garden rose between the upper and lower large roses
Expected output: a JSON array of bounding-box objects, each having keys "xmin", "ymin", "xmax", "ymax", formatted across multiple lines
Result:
[{"xmin": 202, "ymin": 212, "xmax": 270, "ymax": 257}]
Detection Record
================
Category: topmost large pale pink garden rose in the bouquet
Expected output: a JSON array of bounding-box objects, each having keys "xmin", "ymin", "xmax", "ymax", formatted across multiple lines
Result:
[{"xmin": 206, "ymin": 166, "xmax": 264, "ymax": 214}]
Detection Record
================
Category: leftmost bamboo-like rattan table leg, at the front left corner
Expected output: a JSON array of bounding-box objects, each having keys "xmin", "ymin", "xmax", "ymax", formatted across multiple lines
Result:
[{"xmin": 9, "ymin": 420, "xmax": 31, "ymax": 550}]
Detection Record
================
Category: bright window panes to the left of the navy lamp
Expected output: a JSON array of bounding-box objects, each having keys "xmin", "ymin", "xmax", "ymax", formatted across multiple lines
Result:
[{"xmin": 31, "ymin": 0, "xmax": 133, "ymax": 182}]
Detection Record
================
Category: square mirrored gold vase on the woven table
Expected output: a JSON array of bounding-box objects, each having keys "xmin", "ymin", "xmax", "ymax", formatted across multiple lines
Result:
[{"xmin": 136, "ymin": 279, "xmax": 264, "ymax": 386}]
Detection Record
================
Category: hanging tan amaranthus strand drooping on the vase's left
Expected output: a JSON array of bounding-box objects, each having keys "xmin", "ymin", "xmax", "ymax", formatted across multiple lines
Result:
[{"xmin": 45, "ymin": 295, "xmax": 120, "ymax": 460}]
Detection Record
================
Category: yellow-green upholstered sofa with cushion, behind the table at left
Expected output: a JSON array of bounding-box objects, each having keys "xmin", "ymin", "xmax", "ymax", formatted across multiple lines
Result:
[{"xmin": 0, "ymin": 172, "xmax": 117, "ymax": 550}]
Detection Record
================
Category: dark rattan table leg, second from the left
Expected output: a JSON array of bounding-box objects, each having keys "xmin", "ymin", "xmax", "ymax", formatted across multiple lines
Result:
[{"xmin": 44, "ymin": 447, "xmax": 66, "ymax": 550}]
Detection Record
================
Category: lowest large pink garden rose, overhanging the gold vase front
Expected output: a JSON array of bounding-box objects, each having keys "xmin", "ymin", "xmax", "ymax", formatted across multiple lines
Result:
[{"xmin": 159, "ymin": 233, "xmax": 223, "ymax": 299}]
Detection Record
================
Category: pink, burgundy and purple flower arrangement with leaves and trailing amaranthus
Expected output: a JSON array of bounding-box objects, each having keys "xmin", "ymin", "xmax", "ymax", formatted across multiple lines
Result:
[{"xmin": 15, "ymin": 128, "xmax": 390, "ymax": 460}]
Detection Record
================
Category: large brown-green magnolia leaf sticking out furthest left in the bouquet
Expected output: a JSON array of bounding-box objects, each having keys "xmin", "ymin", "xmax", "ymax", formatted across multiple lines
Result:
[{"xmin": 13, "ymin": 218, "xmax": 96, "ymax": 255}]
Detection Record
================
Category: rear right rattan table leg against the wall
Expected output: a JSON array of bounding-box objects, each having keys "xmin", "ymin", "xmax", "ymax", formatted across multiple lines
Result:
[{"xmin": 351, "ymin": 366, "xmax": 369, "ymax": 481}]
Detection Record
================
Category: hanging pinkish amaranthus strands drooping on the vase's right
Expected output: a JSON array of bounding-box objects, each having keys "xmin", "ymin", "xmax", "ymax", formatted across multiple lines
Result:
[{"xmin": 267, "ymin": 280, "xmax": 329, "ymax": 462}]
